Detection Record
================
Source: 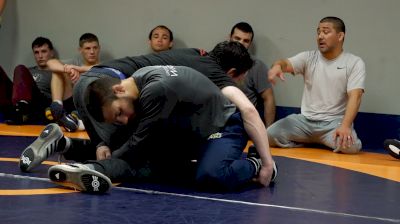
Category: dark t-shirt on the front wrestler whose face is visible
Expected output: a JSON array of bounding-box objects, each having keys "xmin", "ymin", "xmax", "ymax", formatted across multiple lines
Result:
[{"xmin": 114, "ymin": 66, "xmax": 235, "ymax": 157}]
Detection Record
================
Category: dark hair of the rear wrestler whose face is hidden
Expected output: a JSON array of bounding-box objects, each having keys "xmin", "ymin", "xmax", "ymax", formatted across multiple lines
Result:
[{"xmin": 209, "ymin": 41, "xmax": 253, "ymax": 76}]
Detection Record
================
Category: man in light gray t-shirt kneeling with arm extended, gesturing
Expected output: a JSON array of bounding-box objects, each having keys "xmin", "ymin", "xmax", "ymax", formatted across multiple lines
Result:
[{"xmin": 267, "ymin": 17, "xmax": 366, "ymax": 153}]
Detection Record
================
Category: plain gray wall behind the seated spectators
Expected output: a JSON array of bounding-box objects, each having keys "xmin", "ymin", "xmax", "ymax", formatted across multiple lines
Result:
[{"xmin": 0, "ymin": 0, "xmax": 400, "ymax": 114}]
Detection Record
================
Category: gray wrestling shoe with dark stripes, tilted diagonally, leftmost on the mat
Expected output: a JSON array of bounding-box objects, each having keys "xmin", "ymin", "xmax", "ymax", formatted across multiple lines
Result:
[{"xmin": 19, "ymin": 123, "xmax": 70, "ymax": 172}]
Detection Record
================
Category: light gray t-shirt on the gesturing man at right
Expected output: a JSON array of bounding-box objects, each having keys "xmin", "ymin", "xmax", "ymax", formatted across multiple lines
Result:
[{"xmin": 289, "ymin": 50, "xmax": 366, "ymax": 121}]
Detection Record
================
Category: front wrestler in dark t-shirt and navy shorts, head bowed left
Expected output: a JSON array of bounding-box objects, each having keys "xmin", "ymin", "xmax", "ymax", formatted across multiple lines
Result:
[{"xmin": 40, "ymin": 66, "xmax": 277, "ymax": 192}]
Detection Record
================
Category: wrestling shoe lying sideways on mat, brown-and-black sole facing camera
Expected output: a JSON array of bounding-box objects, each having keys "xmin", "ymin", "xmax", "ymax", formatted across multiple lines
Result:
[{"xmin": 48, "ymin": 163, "xmax": 112, "ymax": 193}]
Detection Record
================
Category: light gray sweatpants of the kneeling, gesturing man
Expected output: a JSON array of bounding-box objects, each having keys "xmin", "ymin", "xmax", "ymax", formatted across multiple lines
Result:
[{"xmin": 267, "ymin": 114, "xmax": 362, "ymax": 153}]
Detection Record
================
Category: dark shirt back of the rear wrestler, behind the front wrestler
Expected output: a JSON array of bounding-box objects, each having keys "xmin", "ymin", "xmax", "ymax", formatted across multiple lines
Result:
[{"xmin": 96, "ymin": 48, "xmax": 236, "ymax": 89}]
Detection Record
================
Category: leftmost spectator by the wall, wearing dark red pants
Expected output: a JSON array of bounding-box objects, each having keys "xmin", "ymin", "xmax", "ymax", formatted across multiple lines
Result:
[{"xmin": 0, "ymin": 37, "xmax": 54, "ymax": 125}]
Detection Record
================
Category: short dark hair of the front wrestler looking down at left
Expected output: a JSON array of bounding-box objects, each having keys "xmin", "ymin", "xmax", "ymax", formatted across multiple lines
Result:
[{"xmin": 84, "ymin": 77, "xmax": 121, "ymax": 122}]
